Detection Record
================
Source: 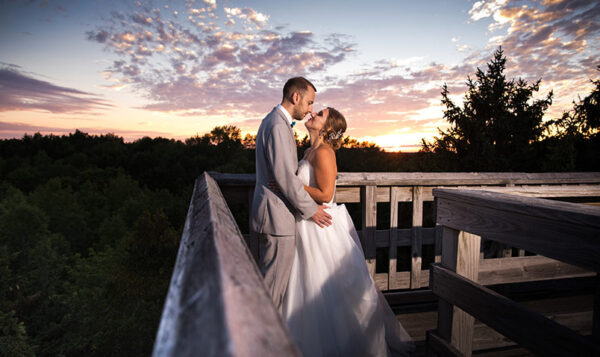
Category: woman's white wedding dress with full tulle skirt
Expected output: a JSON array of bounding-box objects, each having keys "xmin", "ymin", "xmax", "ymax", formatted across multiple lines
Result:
[{"xmin": 283, "ymin": 160, "xmax": 414, "ymax": 357}]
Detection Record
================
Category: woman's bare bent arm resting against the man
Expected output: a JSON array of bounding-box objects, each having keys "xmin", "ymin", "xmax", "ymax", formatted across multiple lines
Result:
[{"xmin": 304, "ymin": 148, "xmax": 337, "ymax": 202}]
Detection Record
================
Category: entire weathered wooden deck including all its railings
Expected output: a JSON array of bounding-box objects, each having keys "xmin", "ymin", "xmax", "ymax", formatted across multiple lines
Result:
[{"xmin": 153, "ymin": 173, "xmax": 600, "ymax": 356}]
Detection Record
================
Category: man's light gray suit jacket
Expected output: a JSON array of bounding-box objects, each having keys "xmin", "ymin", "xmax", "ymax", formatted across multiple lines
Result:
[{"xmin": 250, "ymin": 107, "xmax": 318, "ymax": 236}]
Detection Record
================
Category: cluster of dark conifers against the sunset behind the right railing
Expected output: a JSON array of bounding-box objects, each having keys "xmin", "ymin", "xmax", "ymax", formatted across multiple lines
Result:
[{"xmin": 423, "ymin": 48, "xmax": 600, "ymax": 171}]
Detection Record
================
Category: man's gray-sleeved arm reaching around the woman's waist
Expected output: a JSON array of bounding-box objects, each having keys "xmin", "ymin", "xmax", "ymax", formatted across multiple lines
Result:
[{"xmin": 266, "ymin": 124, "xmax": 318, "ymax": 219}]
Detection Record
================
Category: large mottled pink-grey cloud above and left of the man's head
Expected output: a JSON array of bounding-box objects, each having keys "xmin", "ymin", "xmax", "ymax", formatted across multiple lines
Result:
[{"xmin": 86, "ymin": 0, "xmax": 354, "ymax": 117}]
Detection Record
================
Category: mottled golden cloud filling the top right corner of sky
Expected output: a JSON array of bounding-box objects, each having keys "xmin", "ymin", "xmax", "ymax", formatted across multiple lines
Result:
[{"xmin": 469, "ymin": 0, "xmax": 600, "ymax": 81}]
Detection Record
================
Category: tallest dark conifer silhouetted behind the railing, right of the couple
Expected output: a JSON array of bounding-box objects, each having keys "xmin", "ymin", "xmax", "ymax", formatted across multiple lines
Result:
[{"xmin": 422, "ymin": 48, "xmax": 552, "ymax": 171}]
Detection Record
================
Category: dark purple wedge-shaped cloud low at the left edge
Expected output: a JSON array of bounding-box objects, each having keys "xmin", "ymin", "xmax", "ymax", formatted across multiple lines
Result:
[{"xmin": 0, "ymin": 66, "xmax": 111, "ymax": 113}]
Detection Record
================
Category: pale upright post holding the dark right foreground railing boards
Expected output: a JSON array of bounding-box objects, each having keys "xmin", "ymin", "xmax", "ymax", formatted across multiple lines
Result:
[{"xmin": 438, "ymin": 227, "xmax": 481, "ymax": 356}]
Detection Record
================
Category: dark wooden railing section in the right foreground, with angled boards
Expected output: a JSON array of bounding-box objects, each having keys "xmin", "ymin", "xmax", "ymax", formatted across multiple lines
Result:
[{"xmin": 427, "ymin": 189, "xmax": 600, "ymax": 356}]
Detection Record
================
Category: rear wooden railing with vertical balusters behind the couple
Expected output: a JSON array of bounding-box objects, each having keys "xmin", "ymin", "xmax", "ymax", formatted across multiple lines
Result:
[{"xmin": 211, "ymin": 172, "xmax": 600, "ymax": 296}]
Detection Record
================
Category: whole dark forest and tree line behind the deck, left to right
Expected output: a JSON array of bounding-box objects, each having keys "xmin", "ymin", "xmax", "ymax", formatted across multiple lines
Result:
[{"xmin": 0, "ymin": 50, "xmax": 600, "ymax": 356}]
